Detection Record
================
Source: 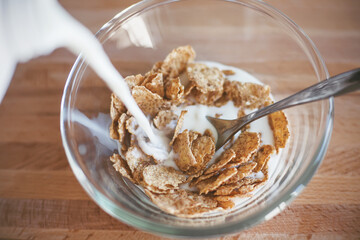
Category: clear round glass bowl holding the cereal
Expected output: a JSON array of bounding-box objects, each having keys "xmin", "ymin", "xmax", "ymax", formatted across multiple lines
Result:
[{"xmin": 60, "ymin": 0, "xmax": 333, "ymax": 237}]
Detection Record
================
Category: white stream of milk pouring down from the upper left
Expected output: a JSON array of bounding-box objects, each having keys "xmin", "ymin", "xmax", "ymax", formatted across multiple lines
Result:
[{"xmin": 0, "ymin": 0, "xmax": 164, "ymax": 148}]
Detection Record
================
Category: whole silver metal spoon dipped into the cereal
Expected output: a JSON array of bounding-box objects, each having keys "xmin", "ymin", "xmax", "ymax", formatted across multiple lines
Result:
[{"xmin": 206, "ymin": 68, "xmax": 360, "ymax": 150}]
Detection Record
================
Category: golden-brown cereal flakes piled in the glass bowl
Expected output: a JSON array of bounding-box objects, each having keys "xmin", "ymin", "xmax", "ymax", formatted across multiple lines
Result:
[{"xmin": 110, "ymin": 46, "xmax": 289, "ymax": 218}]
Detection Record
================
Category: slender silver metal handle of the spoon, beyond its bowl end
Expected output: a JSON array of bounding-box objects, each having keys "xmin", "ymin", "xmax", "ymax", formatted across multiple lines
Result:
[{"xmin": 243, "ymin": 68, "xmax": 360, "ymax": 124}]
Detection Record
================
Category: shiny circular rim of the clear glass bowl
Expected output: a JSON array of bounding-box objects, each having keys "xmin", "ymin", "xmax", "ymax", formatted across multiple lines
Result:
[{"xmin": 60, "ymin": 0, "xmax": 334, "ymax": 237}]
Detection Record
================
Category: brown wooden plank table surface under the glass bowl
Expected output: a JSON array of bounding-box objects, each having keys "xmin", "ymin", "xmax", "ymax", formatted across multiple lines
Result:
[{"xmin": 0, "ymin": 0, "xmax": 360, "ymax": 239}]
